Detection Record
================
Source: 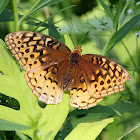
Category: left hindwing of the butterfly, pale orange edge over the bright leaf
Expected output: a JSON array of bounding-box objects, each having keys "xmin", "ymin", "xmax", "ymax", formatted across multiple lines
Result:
[{"xmin": 25, "ymin": 57, "xmax": 69, "ymax": 104}]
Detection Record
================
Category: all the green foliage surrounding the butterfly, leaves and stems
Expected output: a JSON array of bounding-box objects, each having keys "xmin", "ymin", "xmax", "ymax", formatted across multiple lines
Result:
[{"xmin": 0, "ymin": 0, "xmax": 140, "ymax": 140}]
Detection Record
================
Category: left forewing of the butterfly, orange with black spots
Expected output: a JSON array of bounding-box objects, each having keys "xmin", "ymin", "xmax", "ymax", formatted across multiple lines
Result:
[{"xmin": 5, "ymin": 31, "xmax": 70, "ymax": 72}]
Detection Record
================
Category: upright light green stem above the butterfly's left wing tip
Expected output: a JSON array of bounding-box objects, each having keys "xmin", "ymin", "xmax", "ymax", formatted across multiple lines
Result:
[{"xmin": 13, "ymin": 0, "xmax": 19, "ymax": 31}]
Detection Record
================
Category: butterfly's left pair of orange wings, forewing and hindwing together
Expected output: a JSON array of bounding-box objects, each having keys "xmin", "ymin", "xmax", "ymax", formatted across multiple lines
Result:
[{"xmin": 5, "ymin": 31, "xmax": 71, "ymax": 104}]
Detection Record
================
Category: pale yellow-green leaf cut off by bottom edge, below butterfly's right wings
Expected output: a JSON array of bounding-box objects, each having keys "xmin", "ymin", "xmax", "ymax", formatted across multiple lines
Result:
[{"xmin": 65, "ymin": 118, "xmax": 114, "ymax": 140}]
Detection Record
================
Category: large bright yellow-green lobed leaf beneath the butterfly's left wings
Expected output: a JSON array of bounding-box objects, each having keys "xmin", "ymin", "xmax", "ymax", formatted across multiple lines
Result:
[{"xmin": 0, "ymin": 37, "xmax": 69, "ymax": 140}]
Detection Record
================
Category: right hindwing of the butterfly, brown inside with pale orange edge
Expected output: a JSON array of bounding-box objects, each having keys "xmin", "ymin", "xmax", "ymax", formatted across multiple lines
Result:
[{"xmin": 70, "ymin": 62, "xmax": 103, "ymax": 109}]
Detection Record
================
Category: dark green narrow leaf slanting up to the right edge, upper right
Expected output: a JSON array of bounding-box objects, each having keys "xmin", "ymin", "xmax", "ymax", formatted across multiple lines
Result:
[{"xmin": 114, "ymin": 14, "xmax": 140, "ymax": 45}]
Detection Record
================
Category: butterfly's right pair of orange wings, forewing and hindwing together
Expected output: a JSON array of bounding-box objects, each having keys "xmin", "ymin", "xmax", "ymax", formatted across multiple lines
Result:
[{"xmin": 70, "ymin": 54, "xmax": 131, "ymax": 109}]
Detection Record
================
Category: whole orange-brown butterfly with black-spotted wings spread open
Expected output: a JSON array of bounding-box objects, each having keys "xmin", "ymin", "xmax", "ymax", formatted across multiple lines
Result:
[{"xmin": 5, "ymin": 31, "xmax": 131, "ymax": 109}]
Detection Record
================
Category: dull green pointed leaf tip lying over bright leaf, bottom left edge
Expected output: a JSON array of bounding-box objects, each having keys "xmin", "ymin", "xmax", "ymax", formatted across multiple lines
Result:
[{"xmin": 0, "ymin": 119, "xmax": 30, "ymax": 131}]
